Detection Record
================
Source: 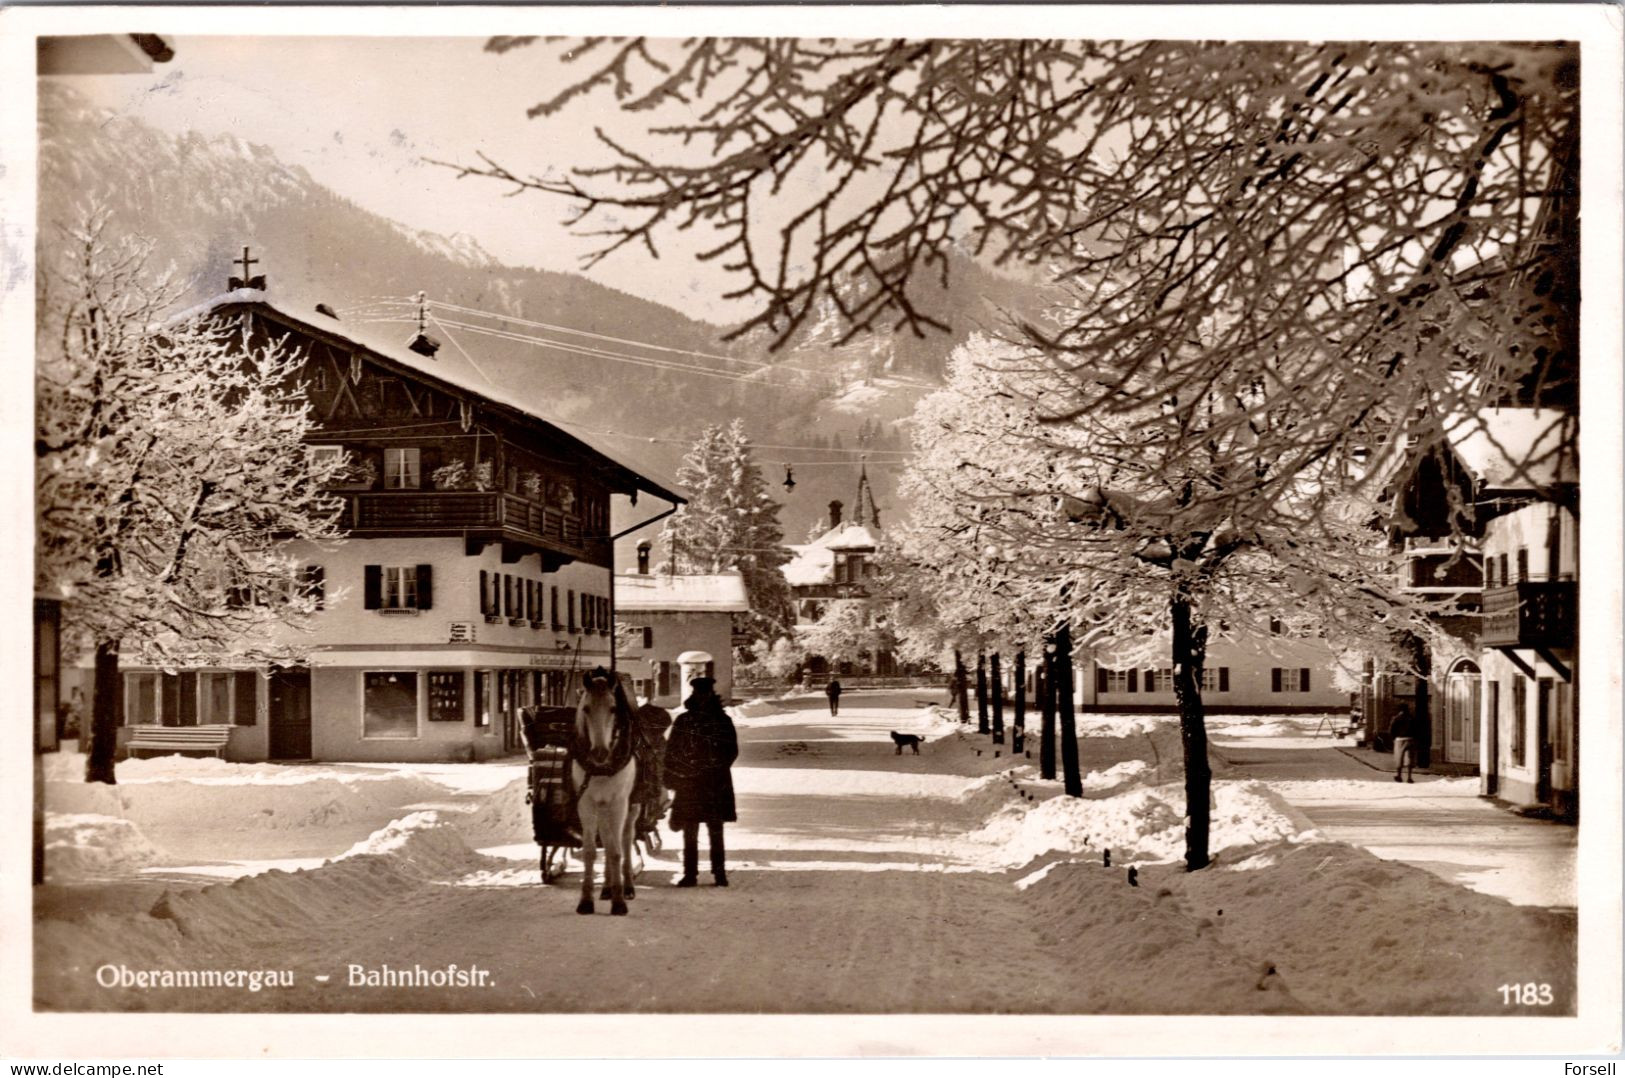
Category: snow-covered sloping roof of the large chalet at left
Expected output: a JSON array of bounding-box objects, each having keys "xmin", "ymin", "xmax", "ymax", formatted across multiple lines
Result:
[{"xmin": 172, "ymin": 288, "xmax": 687, "ymax": 501}]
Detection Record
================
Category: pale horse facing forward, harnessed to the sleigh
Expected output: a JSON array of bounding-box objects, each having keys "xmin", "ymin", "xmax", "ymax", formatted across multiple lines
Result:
[{"xmin": 570, "ymin": 670, "xmax": 637, "ymax": 917}]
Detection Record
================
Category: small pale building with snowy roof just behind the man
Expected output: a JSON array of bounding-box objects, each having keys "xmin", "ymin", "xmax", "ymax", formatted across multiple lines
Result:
[{"xmin": 614, "ymin": 545, "xmax": 751, "ymax": 707}]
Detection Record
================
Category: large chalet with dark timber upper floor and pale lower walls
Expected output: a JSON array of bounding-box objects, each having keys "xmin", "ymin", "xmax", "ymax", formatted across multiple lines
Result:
[{"xmin": 111, "ymin": 280, "xmax": 681, "ymax": 761}]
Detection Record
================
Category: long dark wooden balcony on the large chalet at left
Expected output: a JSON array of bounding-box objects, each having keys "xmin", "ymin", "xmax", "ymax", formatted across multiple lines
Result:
[{"xmin": 345, "ymin": 491, "xmax": 614, "ymax": 567}]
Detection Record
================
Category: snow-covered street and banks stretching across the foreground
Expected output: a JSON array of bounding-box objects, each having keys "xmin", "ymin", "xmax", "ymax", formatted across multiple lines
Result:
[{"xmin": 36, "ymin": 691, "xmax": 1575, "ymax": 1015}]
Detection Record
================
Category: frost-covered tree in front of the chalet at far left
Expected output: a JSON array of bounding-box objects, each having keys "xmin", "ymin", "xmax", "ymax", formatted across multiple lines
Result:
[{"xmin": 34, "ymin": 213, "xmax": 341, "ymax": 782}]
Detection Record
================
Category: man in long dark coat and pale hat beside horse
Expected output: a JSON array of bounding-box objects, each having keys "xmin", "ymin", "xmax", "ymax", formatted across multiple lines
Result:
[{"xmin": 666, "ymin": 678, "xmax": 739, "ymax": 888}]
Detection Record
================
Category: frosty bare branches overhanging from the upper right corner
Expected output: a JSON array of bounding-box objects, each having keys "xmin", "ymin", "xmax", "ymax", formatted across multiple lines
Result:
[{"xmin": 463, "ymin": 37, "xmax": 1580, "ymax": 484}]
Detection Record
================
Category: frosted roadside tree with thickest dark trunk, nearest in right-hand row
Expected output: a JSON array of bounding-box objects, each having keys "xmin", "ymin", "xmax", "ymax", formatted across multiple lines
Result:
[{"xmin": 904, "ymin": 338, "xmax": 1425, "ymax": 868}]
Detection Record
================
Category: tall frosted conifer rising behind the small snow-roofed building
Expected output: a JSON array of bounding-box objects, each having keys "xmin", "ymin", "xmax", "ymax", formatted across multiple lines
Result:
[{"xmin": 660, "ymin": 419, "xmax": 795, "ymax": 645}]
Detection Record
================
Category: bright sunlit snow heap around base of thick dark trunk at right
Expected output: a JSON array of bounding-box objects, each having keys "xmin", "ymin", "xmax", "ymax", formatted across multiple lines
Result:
[{"xmin": 967, "ymin": 782, "xmax": 1318, "ymax": 867}]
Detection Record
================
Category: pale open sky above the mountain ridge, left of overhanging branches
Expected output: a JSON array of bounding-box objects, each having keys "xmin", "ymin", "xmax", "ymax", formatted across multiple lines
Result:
[{"xmin": 62, "ymin": 36, "xmax": 744, "ymax": 320}]
